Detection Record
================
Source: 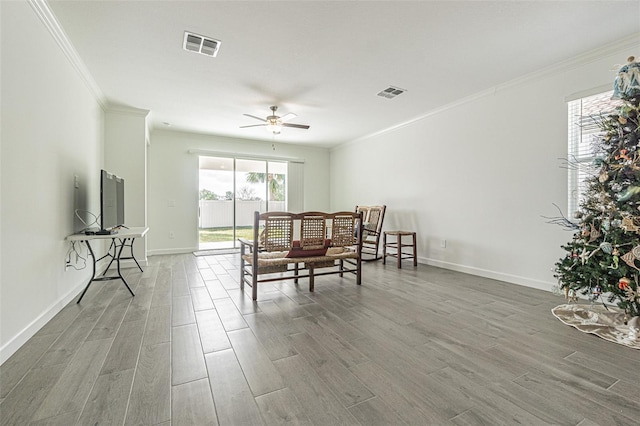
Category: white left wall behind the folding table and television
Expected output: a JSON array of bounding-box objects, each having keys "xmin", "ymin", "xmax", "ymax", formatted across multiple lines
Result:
[{"xmin": 0, "ymin": 1, "xmax": 103, "ymax": 362}]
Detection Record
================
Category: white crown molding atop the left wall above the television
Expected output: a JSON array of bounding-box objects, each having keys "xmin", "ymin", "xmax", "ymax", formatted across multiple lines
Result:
[{"xmin": 27, "ymin": 0, "xmax": 107, "ymax": 109}]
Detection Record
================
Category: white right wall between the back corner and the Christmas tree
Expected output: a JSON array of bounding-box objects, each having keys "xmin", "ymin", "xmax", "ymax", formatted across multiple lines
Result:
[{"xmin": 331, "ymin": 42, "xmax": 640, "ymax": 291}]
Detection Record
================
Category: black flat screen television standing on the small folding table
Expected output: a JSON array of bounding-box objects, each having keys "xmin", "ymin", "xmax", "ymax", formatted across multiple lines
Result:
[{"xmin": 98, "ymin": 170, "xmax": 124, "ymax": 234}]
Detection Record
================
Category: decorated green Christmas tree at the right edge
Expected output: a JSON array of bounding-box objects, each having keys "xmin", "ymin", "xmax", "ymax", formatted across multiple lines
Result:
[{"xmin": 555, "ymin": 57, "xmax": 640, "ymax": 318}]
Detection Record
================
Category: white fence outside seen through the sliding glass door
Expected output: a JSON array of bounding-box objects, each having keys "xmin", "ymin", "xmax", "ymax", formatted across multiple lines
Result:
[{"xmin": 198, "ymin": 200, "xmax": 286, "ymax": 228}]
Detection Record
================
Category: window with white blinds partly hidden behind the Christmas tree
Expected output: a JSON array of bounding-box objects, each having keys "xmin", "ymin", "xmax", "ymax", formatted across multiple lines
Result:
[{"xmin": 568, "ymin": 91, "xmax": 621, "ymax": 219}]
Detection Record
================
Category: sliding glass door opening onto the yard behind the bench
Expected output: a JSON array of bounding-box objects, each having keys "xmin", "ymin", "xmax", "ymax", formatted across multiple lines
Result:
[{"xmin": 198, "ymin": 156, "xmax": 287, "ymax": 250}]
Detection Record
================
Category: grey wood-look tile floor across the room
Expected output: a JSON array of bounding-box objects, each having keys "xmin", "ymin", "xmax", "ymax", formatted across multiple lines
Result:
[{"xmin": 0, "ymin": 254, "xmax": 640, "ymax": 426}]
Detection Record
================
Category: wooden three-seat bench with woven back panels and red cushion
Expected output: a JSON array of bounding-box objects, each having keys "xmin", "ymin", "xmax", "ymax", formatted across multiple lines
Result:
[{"xmin": 238, "ymin": 212, "xmax": 363, "ymax": 300}]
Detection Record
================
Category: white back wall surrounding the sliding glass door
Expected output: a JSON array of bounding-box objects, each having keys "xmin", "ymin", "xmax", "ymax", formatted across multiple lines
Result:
[{"xmin": 148, "ymin": 130, "xmax": 330, "ymax": 254}]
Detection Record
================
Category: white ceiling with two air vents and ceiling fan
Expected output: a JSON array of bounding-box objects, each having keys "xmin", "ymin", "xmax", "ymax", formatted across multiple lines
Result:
[{"xmin": 49, "ymin": 0, "xmax": 640, "ymax": 147}]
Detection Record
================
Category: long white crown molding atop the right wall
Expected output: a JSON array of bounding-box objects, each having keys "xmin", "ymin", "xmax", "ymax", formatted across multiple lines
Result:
[{"xmin": 330, "ymin": 32, "xmax": 640, "ymax": 151}]
